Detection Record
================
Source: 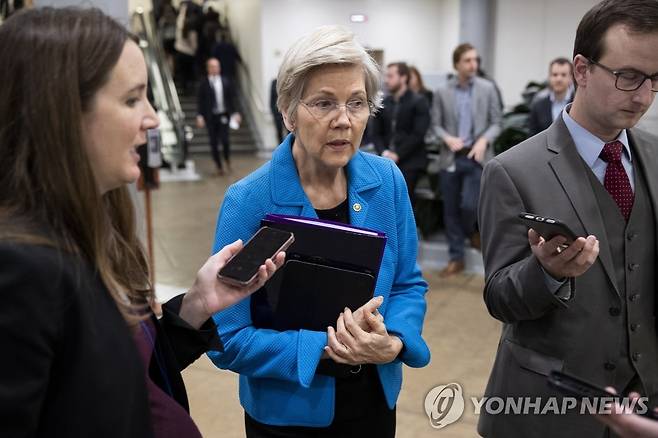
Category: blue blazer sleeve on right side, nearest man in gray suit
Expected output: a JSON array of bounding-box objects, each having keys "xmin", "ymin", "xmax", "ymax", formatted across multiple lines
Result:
[{"xmin": 384, "ymin": 163, "xmax": 430, "ymax": 368}]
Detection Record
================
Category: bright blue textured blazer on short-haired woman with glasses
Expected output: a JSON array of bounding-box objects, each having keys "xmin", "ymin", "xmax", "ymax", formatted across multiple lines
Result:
[{"xmin": 208, "ymin": 134, "xmax": 430, "ymax": 427}]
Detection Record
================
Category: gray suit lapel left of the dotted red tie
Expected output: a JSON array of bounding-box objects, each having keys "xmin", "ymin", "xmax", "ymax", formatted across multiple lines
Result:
[{"xmin": 547, "ymin": 118, "xmax": 619, "ymax": 295}]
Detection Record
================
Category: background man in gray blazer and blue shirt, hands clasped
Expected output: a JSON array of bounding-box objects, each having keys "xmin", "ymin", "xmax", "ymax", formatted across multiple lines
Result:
[{"xmin": 432, "ymin": 43, "xmax": 501, "ymax": 277}]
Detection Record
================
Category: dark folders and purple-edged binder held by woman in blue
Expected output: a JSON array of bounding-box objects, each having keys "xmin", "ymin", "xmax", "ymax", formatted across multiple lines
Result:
[{"xmin": 251, "ymin": 214, "xmax": 386, "ymax": 331}]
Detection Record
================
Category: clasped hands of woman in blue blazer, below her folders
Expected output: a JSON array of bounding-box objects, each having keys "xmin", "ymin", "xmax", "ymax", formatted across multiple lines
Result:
[{"xmin": 324, "ymin": 309, "xmax": 403, "ymax": 365}]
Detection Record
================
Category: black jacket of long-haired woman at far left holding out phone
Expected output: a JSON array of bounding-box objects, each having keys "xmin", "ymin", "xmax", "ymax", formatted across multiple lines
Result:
[{"xmin": 0, "ymin": 242, "xmax": 221, "ymax": 438}]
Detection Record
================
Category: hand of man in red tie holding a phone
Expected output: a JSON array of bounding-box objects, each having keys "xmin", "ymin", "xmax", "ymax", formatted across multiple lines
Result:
[{"xmin": 528, "ymin": 229, "xmax": 599, "ymax": 280}]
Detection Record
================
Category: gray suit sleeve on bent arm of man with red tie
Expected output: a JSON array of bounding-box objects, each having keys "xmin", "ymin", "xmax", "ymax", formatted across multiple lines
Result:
[{"xmin": 478, "ymin": 158, "xmax": 568, "ymax": 323}]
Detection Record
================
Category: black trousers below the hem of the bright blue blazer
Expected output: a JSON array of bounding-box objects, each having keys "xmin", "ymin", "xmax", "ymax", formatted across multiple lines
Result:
[{"xmin": 244, "ymin": 365, "xmax": 395, "ymax": 438}]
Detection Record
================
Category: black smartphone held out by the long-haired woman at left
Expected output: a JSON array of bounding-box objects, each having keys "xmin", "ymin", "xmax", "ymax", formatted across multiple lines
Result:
[{"xmin": 217, "ymin": 227, "xmax": 295, "ymax": 286}]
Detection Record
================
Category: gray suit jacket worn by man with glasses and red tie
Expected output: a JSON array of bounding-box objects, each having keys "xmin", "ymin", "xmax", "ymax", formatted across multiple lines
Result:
[{"xmin": 478, "ymin": 117, "xmax": 658, "ymax": 438}]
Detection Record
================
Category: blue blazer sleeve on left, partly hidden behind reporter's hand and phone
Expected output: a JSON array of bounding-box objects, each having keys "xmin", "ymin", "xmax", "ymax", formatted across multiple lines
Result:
[{"xmin": 208, "ymin": 184, "xmax": 327, "ymax": 387}]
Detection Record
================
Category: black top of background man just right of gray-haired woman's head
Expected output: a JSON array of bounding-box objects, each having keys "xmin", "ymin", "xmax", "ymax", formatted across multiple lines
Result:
[{"xmin": 372, "ymin": 90, "xmax": 430, "ymax": 170}]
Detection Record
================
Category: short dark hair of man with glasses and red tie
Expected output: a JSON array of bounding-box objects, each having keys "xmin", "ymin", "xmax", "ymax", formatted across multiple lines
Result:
[{"xmin": 573, "ymin": 0, "xmax": 658, "ymax": 61}]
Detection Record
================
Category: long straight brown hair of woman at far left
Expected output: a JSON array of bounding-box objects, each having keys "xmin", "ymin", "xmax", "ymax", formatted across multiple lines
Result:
[{"xmin": 0, "ymin": 8, "xmax": 153, "ymax": 323}]
